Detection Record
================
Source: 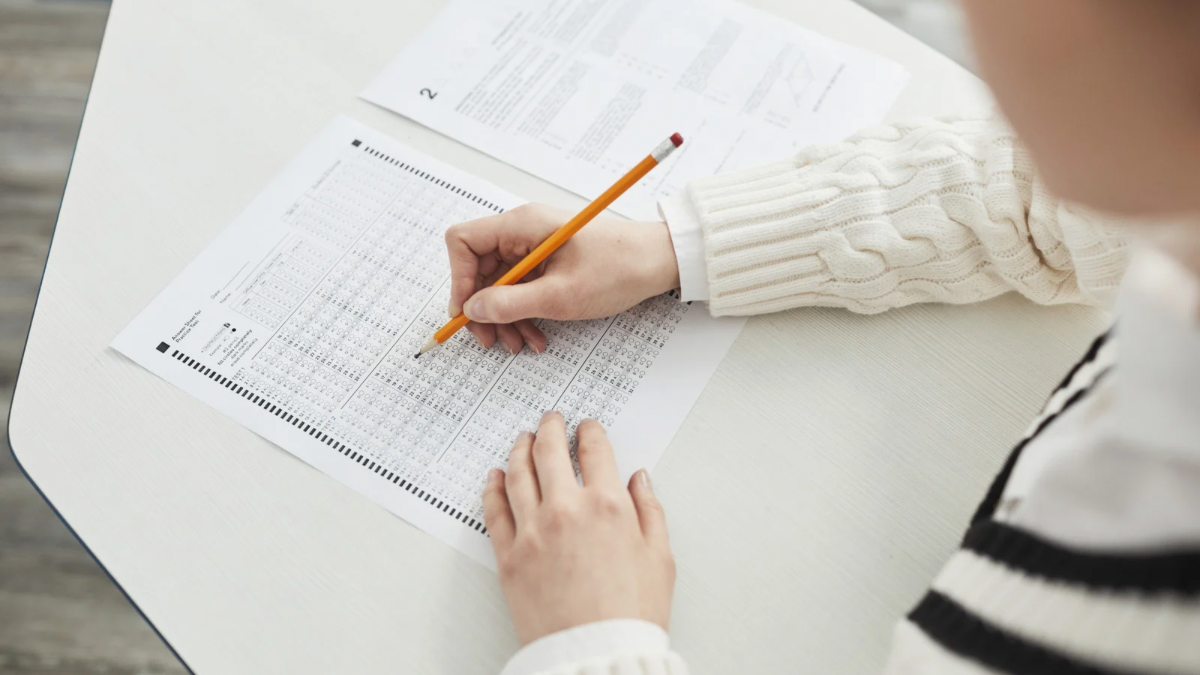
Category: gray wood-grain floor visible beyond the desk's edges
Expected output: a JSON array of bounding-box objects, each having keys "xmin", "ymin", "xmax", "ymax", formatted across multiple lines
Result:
[{"xmin": 0, "ymin": 0, "xmax": 970, "ymax": 675}]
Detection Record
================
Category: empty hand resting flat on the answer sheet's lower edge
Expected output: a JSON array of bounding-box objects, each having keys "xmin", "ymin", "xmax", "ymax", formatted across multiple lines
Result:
[{"xmin": 484, "ymin": 411, "xmax": 674, "ymax": 645}]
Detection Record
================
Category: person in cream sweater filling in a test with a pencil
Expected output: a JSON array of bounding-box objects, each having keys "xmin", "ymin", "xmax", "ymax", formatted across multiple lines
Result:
[{"xmin": 446, "ymin": 0, "xmax": 1200, "ymax": 675}]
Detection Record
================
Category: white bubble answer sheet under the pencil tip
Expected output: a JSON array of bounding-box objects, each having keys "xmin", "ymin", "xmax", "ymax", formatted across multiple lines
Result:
[{"xmin": 113, "ymin": 118, "xmax": 744, "ymax": 568}]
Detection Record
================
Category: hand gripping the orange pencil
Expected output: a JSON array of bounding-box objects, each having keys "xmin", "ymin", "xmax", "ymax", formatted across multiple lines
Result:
[{"xmin": 446, "ymin": 204, "xmax": 679, "ymax": 353}]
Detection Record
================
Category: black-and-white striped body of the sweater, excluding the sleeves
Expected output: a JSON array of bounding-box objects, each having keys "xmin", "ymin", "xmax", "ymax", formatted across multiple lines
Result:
[{"xmin": 888, "ymin": 248, "xmax": 1200, "ymax": 674}]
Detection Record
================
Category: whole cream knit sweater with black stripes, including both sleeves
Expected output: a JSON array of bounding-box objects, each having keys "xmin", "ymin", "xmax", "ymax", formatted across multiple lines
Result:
[{"xmin": 504, "ymin": 115, "xmax": 1200, "ymax": 675}]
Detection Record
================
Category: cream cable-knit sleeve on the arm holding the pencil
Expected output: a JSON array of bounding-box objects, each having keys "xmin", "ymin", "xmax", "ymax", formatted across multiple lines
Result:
[{"xmin": 688, "ymin": 112, "xmax": 1128, "ymax": 315}]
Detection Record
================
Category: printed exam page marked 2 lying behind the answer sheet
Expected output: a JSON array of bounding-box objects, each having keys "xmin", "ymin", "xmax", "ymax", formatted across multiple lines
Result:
[{"xmin": 362, "ymin": 0, "xmax": 908, "ymax": 220}]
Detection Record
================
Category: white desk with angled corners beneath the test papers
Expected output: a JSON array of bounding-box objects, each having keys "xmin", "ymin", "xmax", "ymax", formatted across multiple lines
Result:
[{"xmin": 11, "ymin": 0, "xmax": 1105, "ymax": 675}]
